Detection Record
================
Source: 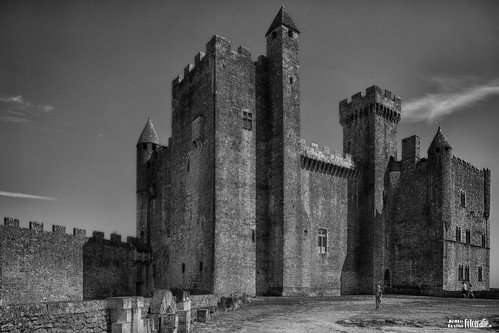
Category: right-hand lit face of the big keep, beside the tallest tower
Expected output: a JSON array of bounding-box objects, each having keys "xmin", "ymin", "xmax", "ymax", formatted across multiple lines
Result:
[{"xmin": 214, "ymin": 37, "xmax": 257, "ymax": 295}]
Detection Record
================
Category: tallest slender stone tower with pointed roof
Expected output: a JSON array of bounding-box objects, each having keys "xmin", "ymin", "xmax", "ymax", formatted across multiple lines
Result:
[{"xmin": 265, "ymin": 6, "xmax": 303, "ymax": 295}]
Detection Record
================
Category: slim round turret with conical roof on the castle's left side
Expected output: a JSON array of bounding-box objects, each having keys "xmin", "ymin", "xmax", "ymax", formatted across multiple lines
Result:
[{"xmin": 137, "ymin": 118, "xmax": 160, "ymax": 243}]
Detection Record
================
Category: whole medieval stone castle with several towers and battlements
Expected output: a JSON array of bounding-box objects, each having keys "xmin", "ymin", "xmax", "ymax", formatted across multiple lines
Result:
[{"xmin": 137, "ymin": 7, "xmax": 490, "ymax": 295}]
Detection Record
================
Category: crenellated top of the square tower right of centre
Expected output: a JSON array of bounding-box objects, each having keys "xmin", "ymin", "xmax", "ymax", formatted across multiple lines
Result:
[{"xmin": 340, "ymin": 85, "xmax": 402, "ymax": 126}]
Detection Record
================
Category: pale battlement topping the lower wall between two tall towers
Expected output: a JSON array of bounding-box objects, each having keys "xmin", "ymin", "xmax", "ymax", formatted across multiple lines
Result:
[{"xmin": 300, "ymin": 139, "xmax": 356, "ymax": 178}]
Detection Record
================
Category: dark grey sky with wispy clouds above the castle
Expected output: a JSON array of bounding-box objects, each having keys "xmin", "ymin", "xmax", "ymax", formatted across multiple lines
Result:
[{"xmin": 0, "ymin": 0, "xmax": 499, "ymax": 287}]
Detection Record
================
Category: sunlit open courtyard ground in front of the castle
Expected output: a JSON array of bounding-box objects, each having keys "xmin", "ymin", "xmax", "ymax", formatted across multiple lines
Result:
[{"xmin": 192, "ymin": 295, "xmax": 499, "ymax": 333}]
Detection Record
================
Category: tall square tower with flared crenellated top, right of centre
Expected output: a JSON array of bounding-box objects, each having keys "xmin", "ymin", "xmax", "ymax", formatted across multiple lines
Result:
[{"xmin": 340, "ymin": 86, "xmax": 401, "ymax": 292}]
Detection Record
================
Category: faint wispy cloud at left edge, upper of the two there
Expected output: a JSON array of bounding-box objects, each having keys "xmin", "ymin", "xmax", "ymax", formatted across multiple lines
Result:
[{"xmin": 0, "ymin": 95, "xmax": 54, "ymax": 123}]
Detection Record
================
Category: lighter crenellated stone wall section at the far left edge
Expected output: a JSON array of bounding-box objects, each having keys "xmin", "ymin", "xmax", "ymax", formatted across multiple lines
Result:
[{"xmin": 0, "ymin": 218, "xmax": 86, "ymax": 304}]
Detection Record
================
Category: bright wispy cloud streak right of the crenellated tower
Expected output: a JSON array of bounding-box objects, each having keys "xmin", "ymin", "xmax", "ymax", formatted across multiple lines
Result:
[{"xmin": 402, "ymin": 77, "xmax": 499, "ymax": 122}]
